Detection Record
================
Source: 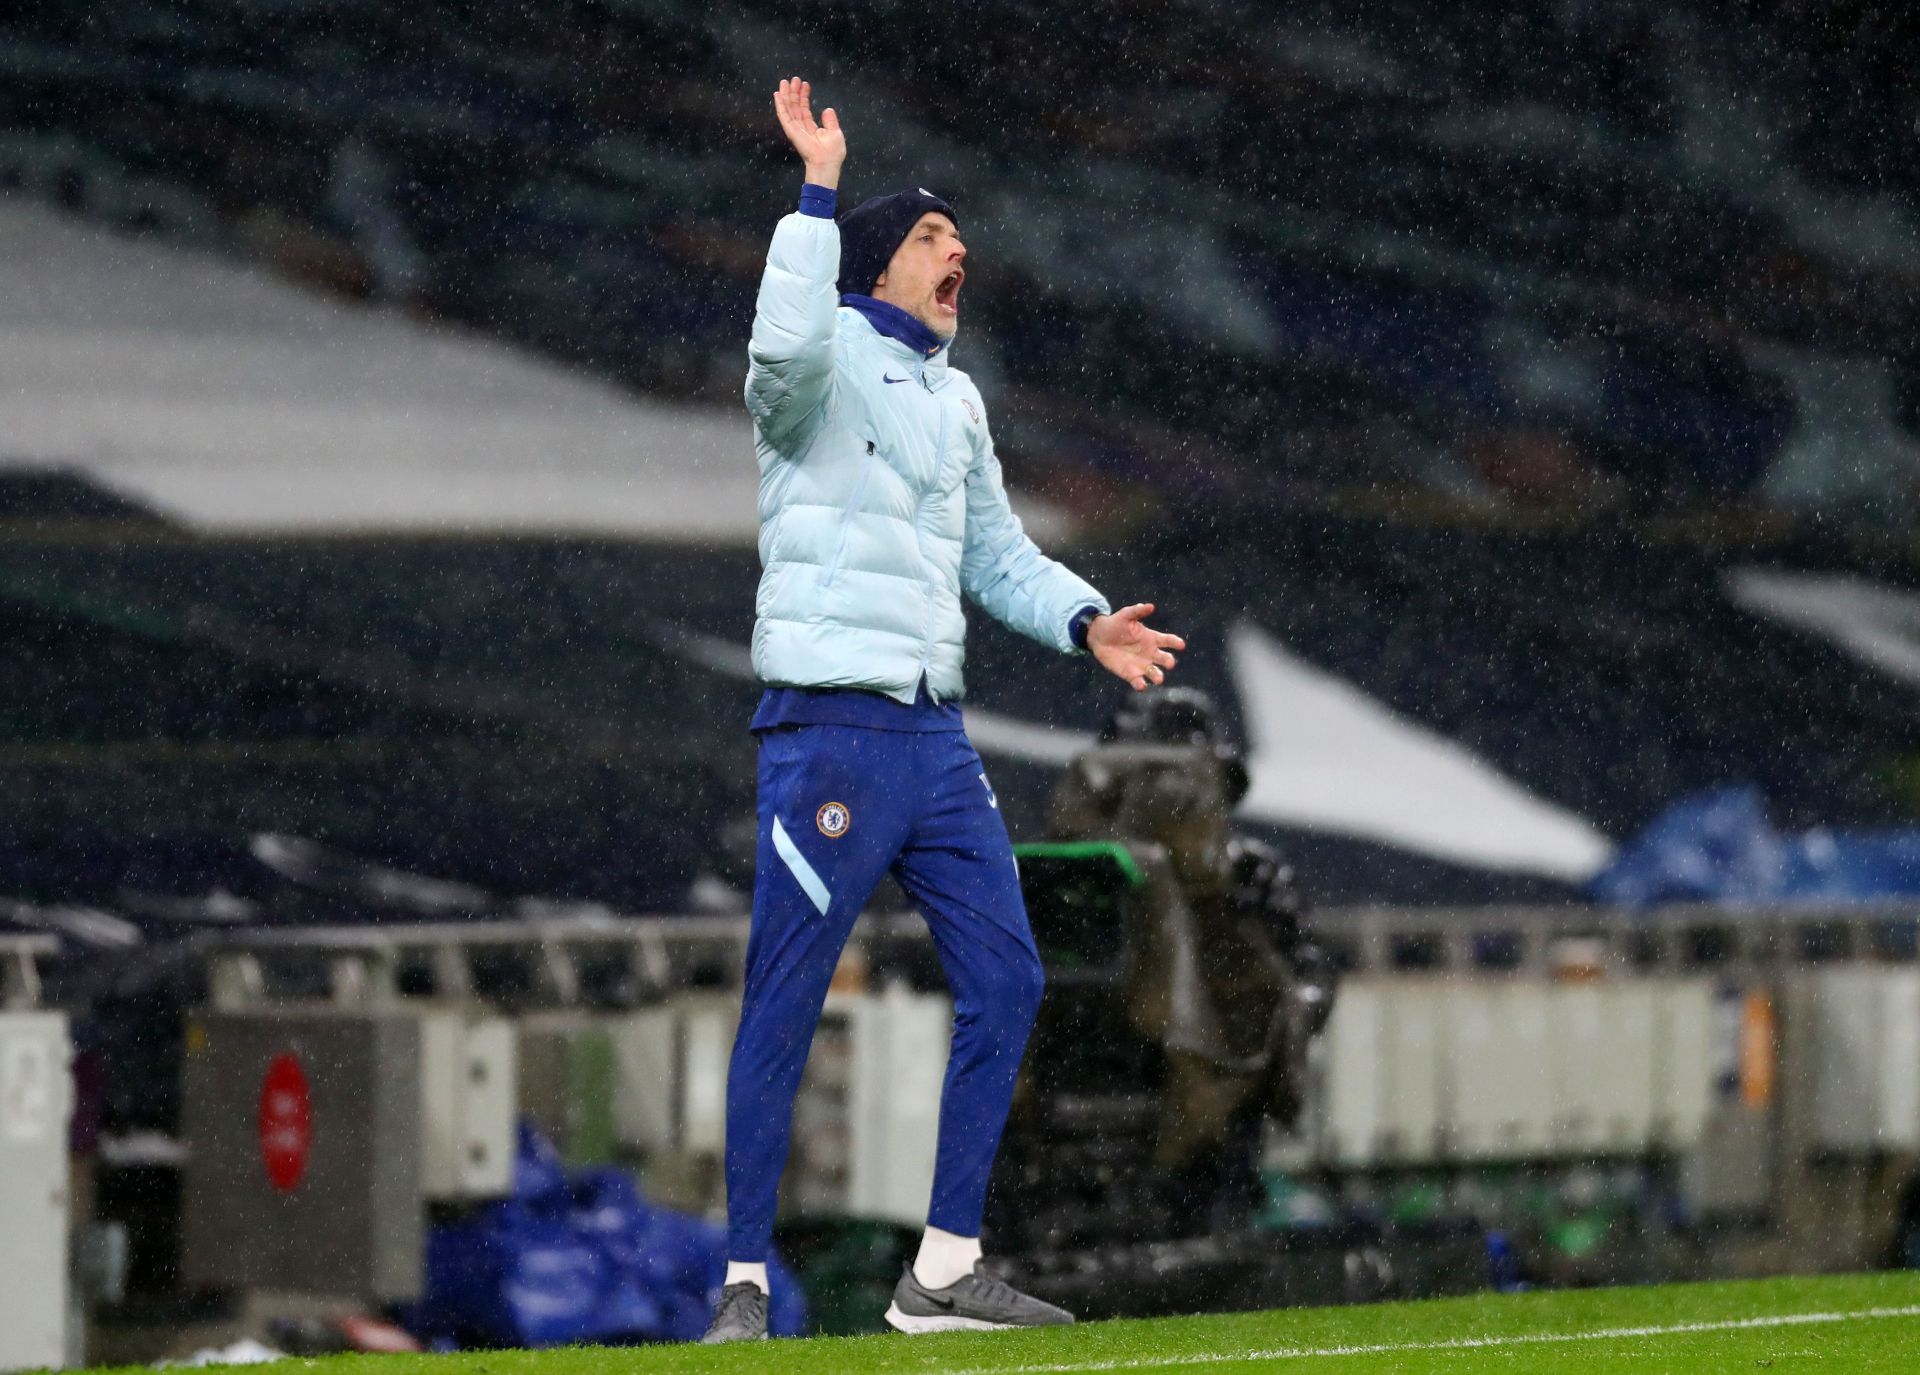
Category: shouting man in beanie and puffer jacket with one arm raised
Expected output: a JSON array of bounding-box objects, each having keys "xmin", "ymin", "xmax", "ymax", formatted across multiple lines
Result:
[{"xmin": 707, "ymin": 79, "xmax": 1187, "ymax": 1342}]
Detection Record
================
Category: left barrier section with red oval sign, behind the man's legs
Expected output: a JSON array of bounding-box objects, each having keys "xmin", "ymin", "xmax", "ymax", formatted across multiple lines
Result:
[{"xmin": 182, "ymin": 918, "xmax": 952, "ymax": 1300}]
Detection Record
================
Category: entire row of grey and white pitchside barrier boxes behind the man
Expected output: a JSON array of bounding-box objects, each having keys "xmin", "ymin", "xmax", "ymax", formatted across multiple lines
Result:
[{"xmin": 182, "ymin": 903, "xmax": 1920, "ymax": 1298}]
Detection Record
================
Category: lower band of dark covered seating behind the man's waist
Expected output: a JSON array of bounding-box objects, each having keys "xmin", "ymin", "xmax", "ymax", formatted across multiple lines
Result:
[{"xmin": 0, "ymin": 489, "xmax": 1910, "ymax": 910}]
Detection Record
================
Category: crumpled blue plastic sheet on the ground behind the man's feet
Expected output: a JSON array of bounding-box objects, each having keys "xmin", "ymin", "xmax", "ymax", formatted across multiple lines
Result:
[{"xmin": 409, "ymin": 1123, "xmax": 806, "ymax": 1346}]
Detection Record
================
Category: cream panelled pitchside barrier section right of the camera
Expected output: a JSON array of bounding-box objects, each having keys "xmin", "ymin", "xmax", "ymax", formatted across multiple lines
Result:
[{"xmin": 1313, "ymin": 905, "xmax": 1920, "ymax": 1273}]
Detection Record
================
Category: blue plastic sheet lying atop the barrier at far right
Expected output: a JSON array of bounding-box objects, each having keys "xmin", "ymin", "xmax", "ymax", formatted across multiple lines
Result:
[{"xmin": 1588, "ymin": 785, "xmax": 1920, "ymax": 906}]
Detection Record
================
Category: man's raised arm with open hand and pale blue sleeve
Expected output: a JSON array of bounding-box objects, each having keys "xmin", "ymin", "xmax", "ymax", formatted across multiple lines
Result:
[{"xmin": 747, "ymin": 77, "xmax": 847, "ymax": 457}]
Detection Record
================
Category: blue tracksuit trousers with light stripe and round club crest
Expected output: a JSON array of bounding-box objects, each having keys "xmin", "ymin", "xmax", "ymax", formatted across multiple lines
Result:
[{"xmin": 726, "ymin": 726, "xmax": 1041, "ymax": 1262}]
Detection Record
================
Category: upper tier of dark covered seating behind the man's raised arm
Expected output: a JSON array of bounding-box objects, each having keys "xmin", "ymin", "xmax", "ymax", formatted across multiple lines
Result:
[{"xmin": 0, "ymin": 0, "xmax": 1920, "ymax": 520}]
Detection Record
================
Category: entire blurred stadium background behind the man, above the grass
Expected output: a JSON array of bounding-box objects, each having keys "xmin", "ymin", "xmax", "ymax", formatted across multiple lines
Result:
[{"xmin": 0, "ymin": 0, "xmax": 1920, "ymax": 1367}]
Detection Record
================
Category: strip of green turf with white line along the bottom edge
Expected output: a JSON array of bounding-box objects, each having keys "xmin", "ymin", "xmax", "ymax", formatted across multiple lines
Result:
[{"xmin": 108, "ymin": 1273, "xmax": 1920, "ymax": 1375}]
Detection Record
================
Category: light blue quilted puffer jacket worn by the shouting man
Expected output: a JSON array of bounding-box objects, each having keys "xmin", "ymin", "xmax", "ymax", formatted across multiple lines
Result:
[{"xmin": 747, "ymin": 213, "xmax": 1110, "ymax": 703}]
